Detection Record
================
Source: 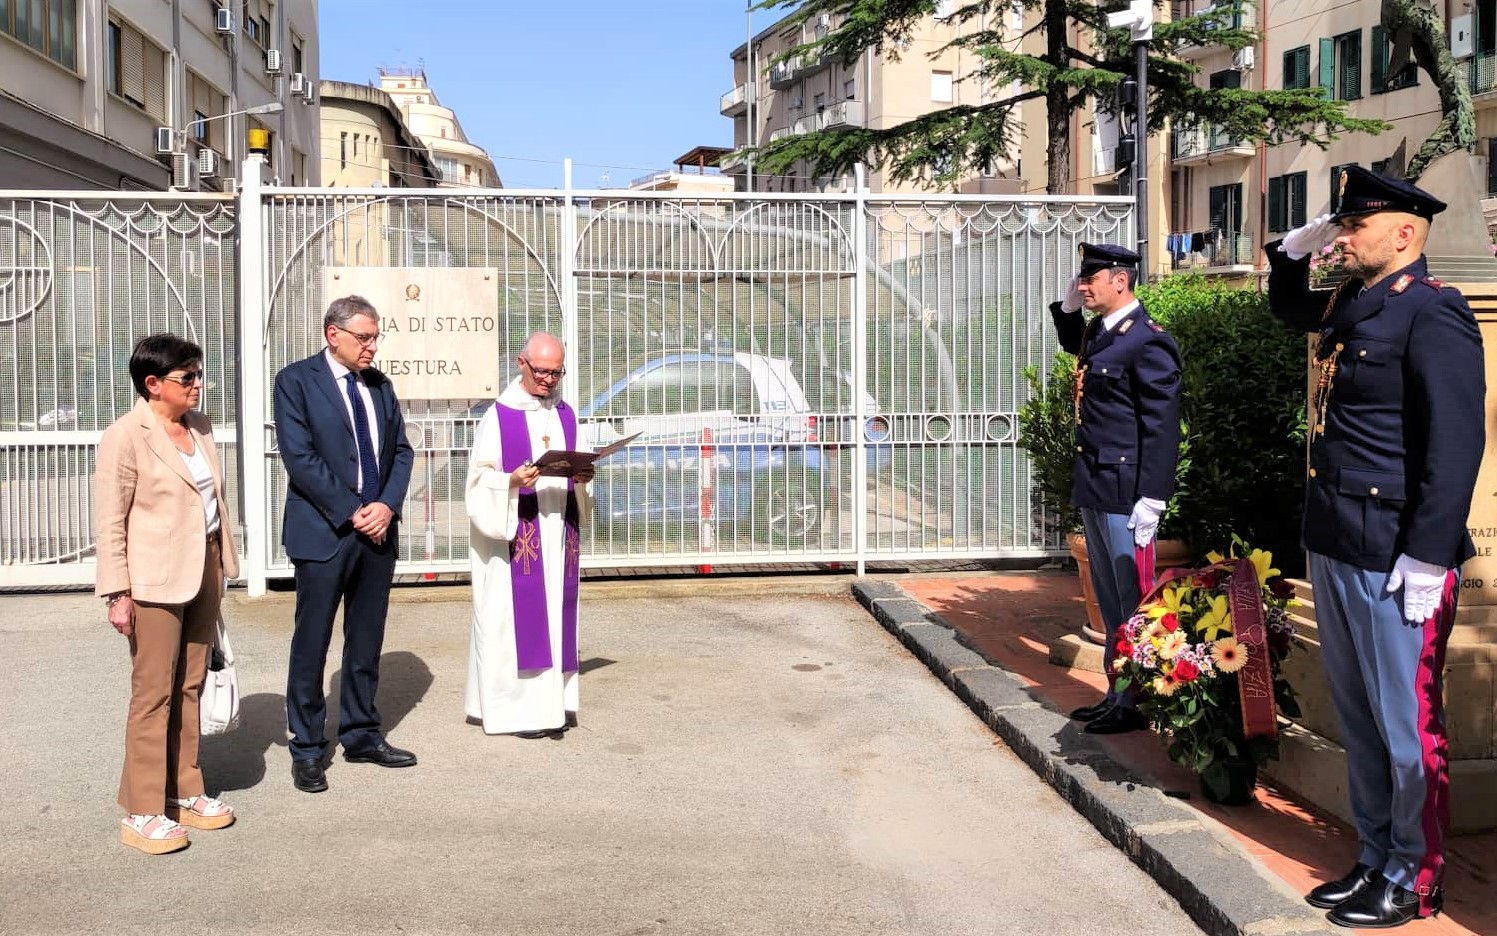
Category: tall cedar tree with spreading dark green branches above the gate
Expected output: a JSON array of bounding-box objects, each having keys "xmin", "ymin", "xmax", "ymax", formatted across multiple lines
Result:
[{"xmin": 754, "ymin": 0, "xmax": 1391, "ymax": 195}]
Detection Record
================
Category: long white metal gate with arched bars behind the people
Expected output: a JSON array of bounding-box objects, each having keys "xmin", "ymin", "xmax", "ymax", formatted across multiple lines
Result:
[{"xmin": 0, "ymin": 174, "xmax": 1133, "ymax": 590}]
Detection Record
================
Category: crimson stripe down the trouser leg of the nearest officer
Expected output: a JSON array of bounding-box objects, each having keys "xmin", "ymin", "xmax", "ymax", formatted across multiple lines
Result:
[{"xmin": 1415, "ymin": 571, "xmax": 1461, "ymax": 917}]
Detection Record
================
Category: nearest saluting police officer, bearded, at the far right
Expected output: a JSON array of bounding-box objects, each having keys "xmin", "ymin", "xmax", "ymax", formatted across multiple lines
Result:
[{"xmin": 1266, "ymin": 166, "xmax": 1485, "ymax": 929}]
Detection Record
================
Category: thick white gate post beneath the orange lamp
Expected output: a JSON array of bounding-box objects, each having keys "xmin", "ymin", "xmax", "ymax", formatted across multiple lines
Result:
[{"xmin": 238, "ymin": 156, "xmax": 271, "ymax": 598}]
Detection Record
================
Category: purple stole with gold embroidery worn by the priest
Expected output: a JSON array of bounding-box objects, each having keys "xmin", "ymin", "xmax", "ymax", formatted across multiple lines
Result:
[{"xmin": 494, "ymin": 403, "xmax": 582, "ymax": 672}]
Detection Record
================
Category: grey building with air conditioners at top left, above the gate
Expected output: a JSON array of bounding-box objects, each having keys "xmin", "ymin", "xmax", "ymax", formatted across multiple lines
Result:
[{"xmin": 0, "ymin": 0, "xmax": 319, "ymax": 190}]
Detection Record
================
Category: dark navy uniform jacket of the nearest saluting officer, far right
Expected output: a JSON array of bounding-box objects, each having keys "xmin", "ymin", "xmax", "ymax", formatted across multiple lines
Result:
[{"xmin": 1266, "ymin": 241, "xmax": 1487, "ymax": 572}]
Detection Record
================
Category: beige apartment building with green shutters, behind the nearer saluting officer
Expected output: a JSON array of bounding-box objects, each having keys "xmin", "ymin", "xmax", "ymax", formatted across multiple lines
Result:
[{"xmin": 1169, "ymin": 0, "xmax": 1497, "ymax": 277}]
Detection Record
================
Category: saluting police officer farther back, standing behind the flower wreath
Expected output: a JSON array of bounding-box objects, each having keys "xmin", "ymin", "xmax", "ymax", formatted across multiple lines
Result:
[{"xmin": 1049, "ymin": 244, "xmax": 1180, "ymax": 734}]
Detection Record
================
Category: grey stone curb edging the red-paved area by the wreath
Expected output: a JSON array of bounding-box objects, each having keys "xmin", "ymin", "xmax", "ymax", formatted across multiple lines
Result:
[{"xmin": 852, "ymin": 581, "xmax": 1334, "ymax": 936}]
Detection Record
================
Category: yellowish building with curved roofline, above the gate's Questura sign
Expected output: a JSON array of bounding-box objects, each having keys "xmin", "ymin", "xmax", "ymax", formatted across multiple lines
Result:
[{"xmin": 317, "ymin": 81, "xmax": 442, "ymax": 189}]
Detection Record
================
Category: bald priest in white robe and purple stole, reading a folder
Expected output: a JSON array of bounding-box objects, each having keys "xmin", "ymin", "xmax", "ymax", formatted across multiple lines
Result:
[{"xmin": 464, "ymin": 332, "xmax": 593, "ymax": 738}]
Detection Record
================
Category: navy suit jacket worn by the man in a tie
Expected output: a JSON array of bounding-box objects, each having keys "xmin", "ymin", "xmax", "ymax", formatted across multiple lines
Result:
[{"xmin": 274, "ymin": 352, "xmax": 416, "ymax": 562}]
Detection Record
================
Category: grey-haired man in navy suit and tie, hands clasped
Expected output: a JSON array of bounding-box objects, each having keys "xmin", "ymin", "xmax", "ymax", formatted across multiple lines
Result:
[{"xmin": 275, "ymin": 295, "xmax": 416, "ymax": 792}]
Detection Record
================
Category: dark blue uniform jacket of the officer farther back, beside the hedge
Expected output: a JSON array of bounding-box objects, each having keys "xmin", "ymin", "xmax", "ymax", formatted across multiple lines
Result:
[{"xmin": 1049, "ymin": 303, "xmax": 1180, "ymax": 514}]
